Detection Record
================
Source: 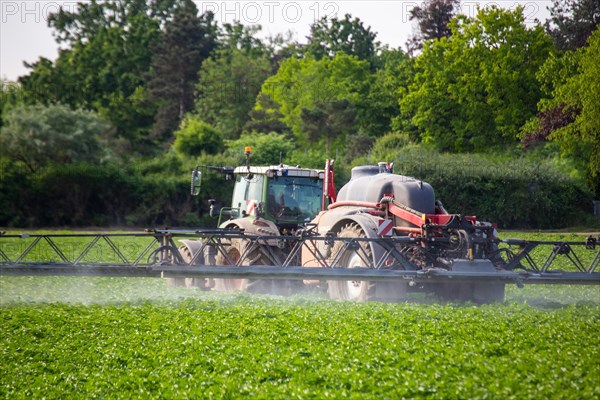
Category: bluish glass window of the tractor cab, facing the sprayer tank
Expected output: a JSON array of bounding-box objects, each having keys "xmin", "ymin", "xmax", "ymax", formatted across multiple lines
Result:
[{"xmin": 267, "ymin": 176, "xmax": 323, "ymax": 223}]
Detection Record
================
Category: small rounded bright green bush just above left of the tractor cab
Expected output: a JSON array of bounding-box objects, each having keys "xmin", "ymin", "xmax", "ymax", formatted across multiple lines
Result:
[{"xmin": 173, "ymin": 115, "xmax": 225, "ymax": 157}]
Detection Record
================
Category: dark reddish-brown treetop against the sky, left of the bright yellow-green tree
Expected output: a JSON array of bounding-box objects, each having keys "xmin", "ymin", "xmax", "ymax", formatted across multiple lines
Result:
[{"xmin": 406, "ymin": 0, "xmax": 459, "ymax": 55}]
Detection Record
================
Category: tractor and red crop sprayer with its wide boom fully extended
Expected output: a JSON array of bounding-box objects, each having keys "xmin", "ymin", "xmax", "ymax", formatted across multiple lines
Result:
[{"xmin": 0, "ymin": 148, "xmax": 600, "ymax": 303}]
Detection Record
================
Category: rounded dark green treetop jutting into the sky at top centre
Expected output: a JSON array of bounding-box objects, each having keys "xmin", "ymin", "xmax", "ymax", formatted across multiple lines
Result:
[{"xmin": 305, "ymin": 14, "xmax": 380, "ymax": 63}]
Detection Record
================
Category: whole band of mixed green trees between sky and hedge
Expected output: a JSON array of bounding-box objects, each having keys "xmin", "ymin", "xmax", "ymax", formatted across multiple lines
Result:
[{"xmin": 0, "ymin": 0, "xmax": 600, "ymax": 224}]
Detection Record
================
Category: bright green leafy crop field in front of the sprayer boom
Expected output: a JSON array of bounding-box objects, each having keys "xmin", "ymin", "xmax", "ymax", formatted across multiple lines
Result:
[{"xmin": 0, "ymin": 232, "xmax": 600, "ymax": 399}]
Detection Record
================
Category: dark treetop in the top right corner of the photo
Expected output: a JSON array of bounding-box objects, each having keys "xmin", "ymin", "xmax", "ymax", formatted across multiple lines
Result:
[{"xmin": 545, "ymin": 0, "xmax": 600, "ymax": 50}]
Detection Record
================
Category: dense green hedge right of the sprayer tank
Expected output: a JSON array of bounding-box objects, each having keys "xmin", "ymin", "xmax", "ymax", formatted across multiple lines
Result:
[{"xmin": 396, "ymin": 148, "xmax": 593, "ymax": 229}]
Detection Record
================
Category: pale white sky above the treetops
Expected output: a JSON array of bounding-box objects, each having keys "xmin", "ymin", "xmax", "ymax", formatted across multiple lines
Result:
[{"xmin": 0, "ymin": 0, "xmax": 552, "ymax": 81}]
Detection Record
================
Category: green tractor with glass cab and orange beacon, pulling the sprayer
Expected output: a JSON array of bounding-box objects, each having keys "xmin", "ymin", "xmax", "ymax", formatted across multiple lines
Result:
[{"xmin": 175, "ymin": 148, "xmax": 336, "ymax": 294}]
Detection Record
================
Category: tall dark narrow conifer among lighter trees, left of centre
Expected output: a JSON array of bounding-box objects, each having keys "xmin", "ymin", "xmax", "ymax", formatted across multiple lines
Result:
[{"xmin": 148, "ymin": 0, "xmax": 216, "ymax": 143}]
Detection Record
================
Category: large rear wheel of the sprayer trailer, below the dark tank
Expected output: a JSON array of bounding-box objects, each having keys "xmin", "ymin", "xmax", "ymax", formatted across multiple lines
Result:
[{"xmin": 328, "ymin": 223, "xmax": 406, "ymax": 302}]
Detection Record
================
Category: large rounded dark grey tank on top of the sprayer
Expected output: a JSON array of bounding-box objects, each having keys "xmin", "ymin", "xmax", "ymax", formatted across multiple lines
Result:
[{"xmin": 337, "ymin": 165, "xmax": 435, "ymax": 214}]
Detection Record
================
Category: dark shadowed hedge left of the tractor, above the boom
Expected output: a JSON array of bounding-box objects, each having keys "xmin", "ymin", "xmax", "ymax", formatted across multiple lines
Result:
[{"xmin": 0, "ymin": 160, "xmax": 232, "ymax": 227}]
